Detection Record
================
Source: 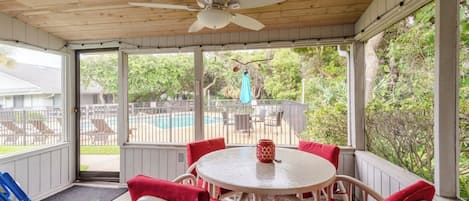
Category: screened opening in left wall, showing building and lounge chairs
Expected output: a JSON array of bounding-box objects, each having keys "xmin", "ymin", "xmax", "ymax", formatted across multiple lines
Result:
[{"xmin": 0, "ymin": 44, "xmax": 64, "ymax": 156}]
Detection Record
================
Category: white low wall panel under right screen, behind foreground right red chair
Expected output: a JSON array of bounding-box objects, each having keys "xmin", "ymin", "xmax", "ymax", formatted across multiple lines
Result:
[{"xmin": 355, "ymin": 151, "xmax": 422, "ymax": 197}]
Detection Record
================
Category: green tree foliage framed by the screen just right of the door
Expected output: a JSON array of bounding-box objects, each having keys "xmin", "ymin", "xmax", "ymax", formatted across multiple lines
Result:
[{"xmin": 128, "ymin": 54, "xmax": 194, "ymax": 102}]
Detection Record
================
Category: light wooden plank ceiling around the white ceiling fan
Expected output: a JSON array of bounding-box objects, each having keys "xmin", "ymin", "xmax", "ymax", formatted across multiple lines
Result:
[{"xmin": 0, "ymin": 0, "xmax": 371, "ymax": 40}]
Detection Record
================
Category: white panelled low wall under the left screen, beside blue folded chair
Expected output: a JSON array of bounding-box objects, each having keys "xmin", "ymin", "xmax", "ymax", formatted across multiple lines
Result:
[{"xmin": 0, "ymin": 144, "xmax": 71, "ymax": 200}]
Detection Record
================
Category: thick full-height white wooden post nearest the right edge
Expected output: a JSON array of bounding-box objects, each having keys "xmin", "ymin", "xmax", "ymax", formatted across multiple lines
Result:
[{"xmin": 434, "ymin": 0, "xmax": 459, "ymax": 200}]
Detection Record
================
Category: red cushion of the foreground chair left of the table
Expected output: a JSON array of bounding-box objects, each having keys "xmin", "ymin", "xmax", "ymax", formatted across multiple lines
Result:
[{"xmin": 127, "ymin": 175, "xmax": 210, "ymax": 201}]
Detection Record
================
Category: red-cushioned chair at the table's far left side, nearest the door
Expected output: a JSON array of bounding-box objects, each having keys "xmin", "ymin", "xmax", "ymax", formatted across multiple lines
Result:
[{"xmin": 186, "ymin": 138, "xmax": 235, "ymax": 199}]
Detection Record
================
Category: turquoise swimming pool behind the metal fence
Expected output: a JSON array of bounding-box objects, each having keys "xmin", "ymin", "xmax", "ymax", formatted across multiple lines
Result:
[{"xmin": 80, "ymin": 114, "xmax": 223, "ymax": 130}]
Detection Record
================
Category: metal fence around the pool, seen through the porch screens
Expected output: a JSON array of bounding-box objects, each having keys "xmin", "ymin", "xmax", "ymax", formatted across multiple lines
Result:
[{"xmin": 0, "ymin": 100, "xmax": 308, "ymax": 145}]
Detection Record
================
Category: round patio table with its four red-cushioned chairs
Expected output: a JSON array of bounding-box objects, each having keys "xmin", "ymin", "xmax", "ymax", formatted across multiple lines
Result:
[{"xmin": 127, "ymin": 138, "xmax": 435, "ymax": 201}]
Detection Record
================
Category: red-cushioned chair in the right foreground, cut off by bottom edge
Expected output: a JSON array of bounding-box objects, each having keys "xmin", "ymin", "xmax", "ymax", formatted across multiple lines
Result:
[{"xmin": 329, "ymin": 175, "xmax": 435, "ymax": 201}]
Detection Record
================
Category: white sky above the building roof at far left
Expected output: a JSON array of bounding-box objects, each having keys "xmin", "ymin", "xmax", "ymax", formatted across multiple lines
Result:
[{"xmin": 0, "ymin": 44, "xmax": 62, "ymax": 68}]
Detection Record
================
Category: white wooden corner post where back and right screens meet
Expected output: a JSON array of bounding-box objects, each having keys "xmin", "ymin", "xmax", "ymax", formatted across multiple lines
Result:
[{"xmin": 347, "ymin": 41, "xmax": 365, "ymax": 150}]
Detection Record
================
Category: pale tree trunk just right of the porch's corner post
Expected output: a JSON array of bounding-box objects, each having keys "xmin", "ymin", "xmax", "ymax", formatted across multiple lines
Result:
[{"xmin": 365, "ymin": 32, "xmax": 384, "ymax": 105}]
